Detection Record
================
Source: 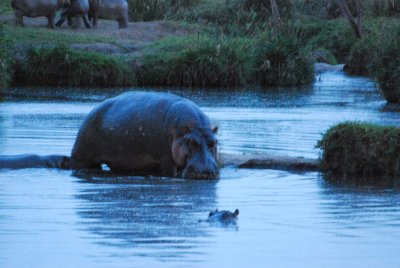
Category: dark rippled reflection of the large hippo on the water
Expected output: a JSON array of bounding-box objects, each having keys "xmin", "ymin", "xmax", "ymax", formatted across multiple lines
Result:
[{"xmin": 76, "ymin": 172, "xmax": 216, "ymax": 251}]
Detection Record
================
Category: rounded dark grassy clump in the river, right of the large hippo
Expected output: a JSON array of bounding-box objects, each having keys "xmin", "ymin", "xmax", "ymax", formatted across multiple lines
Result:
[{"xmin": 317, "ymin": 122, "xmax": 400, "ymax": 177}]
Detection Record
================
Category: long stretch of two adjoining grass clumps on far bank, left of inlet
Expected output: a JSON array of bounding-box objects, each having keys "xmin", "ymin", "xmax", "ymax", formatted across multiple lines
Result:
[{"xmin": 137, "ymin": 32, "xmax": 314, "ymax": 87}]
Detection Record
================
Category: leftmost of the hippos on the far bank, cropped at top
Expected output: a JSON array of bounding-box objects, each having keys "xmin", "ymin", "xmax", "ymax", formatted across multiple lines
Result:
[{"xmin": 11, "ymin": 0, "xmax": 70, "ymax": 28}]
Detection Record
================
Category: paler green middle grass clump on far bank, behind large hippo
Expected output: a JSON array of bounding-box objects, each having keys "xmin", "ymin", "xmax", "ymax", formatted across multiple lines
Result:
[{"xmin": 137, "ymin": 35, "xmax": 254, "ymax": 87}]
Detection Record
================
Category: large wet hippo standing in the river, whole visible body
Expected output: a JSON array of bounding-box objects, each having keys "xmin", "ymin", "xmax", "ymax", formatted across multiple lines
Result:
[{"xmin": 69, "ymin": 92, "xmax": 219, "ymax": 179}]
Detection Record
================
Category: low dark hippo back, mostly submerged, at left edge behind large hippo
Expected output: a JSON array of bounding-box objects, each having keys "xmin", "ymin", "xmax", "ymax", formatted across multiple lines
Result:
[{"xmin": 0, "ymin": 154, "xmax": 69, "ymax": 169}]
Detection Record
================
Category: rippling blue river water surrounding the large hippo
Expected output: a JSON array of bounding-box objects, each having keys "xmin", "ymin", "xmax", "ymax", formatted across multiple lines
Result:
[{"xmin": 0, "ymin": 68, "xmax": 400, "ymax": 268}]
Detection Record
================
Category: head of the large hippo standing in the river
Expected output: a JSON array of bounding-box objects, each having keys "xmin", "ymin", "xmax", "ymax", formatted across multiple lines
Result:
[{"xmin": 172, "ymin": 127, "xmax": 219, "ymax": 179}]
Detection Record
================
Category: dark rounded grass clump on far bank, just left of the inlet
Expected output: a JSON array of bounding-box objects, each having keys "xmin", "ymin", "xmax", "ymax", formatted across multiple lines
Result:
[{"xmin": 256, "ymin": 35, "xmax": 314, "ymax": 85}]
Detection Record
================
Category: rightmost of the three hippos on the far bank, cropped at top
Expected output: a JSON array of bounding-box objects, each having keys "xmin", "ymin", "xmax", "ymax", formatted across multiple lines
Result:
[{"xmin": 89, "ymin": 0, "xmax": 128, "ymax": 28}]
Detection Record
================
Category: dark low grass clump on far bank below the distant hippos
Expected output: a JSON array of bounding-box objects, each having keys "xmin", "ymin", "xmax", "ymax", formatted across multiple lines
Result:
[{"xmin": 18, "ymin": 46, "xmax": 136, "ymax": 87}]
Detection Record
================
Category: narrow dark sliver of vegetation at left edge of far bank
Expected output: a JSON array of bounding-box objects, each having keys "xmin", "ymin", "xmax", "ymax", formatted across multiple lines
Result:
[{"xmin": 0, "ymin": 24, "xmax": 13, "ymax": 89}]
